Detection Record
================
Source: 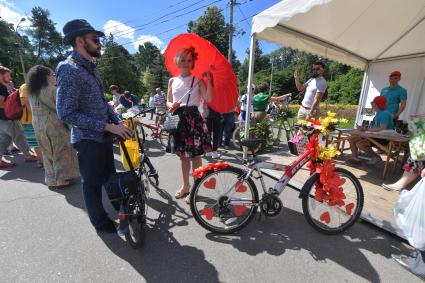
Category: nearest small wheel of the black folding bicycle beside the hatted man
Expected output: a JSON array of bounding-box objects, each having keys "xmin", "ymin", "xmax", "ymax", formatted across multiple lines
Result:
[{"xmin": 125, "ymin": 191, "xmax": 146, "ymax": 248}]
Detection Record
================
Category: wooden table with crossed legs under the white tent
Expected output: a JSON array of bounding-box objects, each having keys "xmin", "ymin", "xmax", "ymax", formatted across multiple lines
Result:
[{"xmin": 351, "ymin": 130, "xmax": 409, "ymax": 179}]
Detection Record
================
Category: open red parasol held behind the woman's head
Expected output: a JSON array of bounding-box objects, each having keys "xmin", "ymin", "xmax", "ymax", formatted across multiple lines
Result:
[{"xmin": 164, "ymin": 33, "xmax": 238, "ymax": 113}]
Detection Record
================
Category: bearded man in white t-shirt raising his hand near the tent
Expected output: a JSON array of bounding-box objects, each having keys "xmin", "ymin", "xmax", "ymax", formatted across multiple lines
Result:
[{"xmin": 294, "ymin": 62, "xmax": 326, "ymax": 120}]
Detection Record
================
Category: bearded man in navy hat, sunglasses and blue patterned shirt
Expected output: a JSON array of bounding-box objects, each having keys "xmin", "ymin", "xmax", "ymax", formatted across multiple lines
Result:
[{"xmin": 56, "ymin": 19, "xmax": 133, "ymax": 233}]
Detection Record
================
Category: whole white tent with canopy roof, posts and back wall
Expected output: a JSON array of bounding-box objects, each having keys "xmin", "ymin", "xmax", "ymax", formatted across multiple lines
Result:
[{"xmin": 243, "ymin": 0, "xmax": 425, "ymax": 144}]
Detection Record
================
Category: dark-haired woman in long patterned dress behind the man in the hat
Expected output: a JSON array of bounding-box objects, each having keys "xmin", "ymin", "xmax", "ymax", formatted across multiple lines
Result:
[{"xmin": 26, "ymin": 65, "xmax": 79, "ymax": 189}]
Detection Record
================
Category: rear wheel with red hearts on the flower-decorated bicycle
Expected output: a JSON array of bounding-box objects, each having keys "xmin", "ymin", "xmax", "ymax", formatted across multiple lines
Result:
[{"xmin": 190, "ymin": 166, "xmax": 259, "ymax": 234}]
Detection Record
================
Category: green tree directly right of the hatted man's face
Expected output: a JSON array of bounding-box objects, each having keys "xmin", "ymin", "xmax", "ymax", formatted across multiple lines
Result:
[{"xmin": 96, "ymin": 35, "xmax": 140, "ymax": 95}]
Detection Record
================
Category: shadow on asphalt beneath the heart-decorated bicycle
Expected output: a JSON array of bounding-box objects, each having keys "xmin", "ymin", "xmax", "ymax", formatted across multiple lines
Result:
[{"xmin": 206, "ymin": 208, "xmax": 410, "ymax": 282}]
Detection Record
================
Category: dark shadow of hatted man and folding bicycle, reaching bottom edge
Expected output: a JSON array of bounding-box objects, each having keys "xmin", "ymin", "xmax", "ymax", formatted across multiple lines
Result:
[{"xmin": 96, "ymin": 190, "xmax": 219, "ymax": 282}]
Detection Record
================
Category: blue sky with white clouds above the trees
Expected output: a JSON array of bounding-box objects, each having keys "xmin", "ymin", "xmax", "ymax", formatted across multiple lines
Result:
[{"xmin": 0, "ymin": 0, "xmax": 279, "ymax": 61}]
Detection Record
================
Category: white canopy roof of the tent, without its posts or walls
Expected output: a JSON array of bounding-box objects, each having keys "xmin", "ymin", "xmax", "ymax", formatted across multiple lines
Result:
[{"xmin": 251, "ymin": 0, "xmax": 425, "ymax": 70}]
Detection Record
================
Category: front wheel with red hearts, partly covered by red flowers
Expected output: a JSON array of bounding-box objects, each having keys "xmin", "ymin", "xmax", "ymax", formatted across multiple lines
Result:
[{"xmin": 302, "ymin": 168, "xmax": 363, "ymax": 235}]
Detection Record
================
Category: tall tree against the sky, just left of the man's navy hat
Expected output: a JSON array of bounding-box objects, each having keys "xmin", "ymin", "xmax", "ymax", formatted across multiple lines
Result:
[{"xmin": 27, "ymin": 6, "xmax": 65, "ymax": 68}]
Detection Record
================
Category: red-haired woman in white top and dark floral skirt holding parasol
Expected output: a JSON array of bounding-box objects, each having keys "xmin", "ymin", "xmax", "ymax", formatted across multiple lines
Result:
[{"xmin": 167, "ymin": 48, "xmax": 213, "ymax": 203}]
